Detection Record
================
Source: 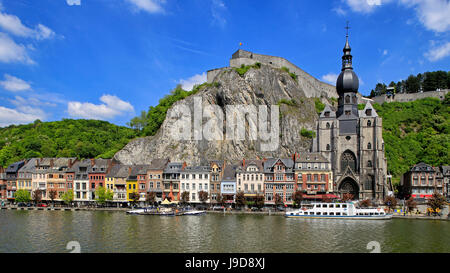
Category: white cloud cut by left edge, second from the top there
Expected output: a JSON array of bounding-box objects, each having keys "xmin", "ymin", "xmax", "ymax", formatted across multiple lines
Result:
[{"xmin": 0, "ymin": 32, "xmax": 34, "ymax": 64}]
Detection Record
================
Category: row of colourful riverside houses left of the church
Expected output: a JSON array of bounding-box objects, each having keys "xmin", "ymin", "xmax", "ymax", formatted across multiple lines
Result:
[{"xmin": 0, "ymin": 153, "xmax": 334, "ymax": 205}]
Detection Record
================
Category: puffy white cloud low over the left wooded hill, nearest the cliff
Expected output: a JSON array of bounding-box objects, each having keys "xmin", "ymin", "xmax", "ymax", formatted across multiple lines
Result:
[{"xmin": 67, "ymin": 95, "xmax": 134, "ymax": 120}]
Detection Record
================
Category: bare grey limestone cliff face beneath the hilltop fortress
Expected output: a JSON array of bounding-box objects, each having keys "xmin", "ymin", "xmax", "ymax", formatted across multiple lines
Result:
[{"xmin": 114, "ymin": 64, "xmax": 332, "ymax": 165}]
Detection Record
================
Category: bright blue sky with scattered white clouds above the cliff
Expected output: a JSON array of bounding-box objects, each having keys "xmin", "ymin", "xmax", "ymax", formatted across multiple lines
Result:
[{"xmin": 0, "ymin": 0, "xmax": 450, "ymax": 127}]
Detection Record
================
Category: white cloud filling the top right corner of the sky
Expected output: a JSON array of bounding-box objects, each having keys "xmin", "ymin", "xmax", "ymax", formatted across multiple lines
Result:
[{"xmin": 400, "ymin": 0, "xmax": 450, "ymax": 32}]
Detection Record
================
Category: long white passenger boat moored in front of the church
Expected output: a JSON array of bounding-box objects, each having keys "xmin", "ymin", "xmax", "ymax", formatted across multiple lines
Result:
[{"xmin": 285, "ymin": 203, "xmax": 392, "ymax": 220}]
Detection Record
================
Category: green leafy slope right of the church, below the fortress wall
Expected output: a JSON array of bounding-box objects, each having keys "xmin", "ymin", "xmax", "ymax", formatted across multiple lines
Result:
[{"xmin": 374, "ymin": 93, "xmax": 450, "ymax": 181}]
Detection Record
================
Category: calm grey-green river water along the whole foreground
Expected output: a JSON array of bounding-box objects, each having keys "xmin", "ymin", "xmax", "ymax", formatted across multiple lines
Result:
[{"xmin": 0, "ymin": 210, "xmax": 450, "ymax": 253}]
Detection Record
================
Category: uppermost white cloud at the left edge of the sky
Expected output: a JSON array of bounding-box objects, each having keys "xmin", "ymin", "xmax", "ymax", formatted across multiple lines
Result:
[{"xmin": 0, "ymin": 7, "xmax": 55, "ymax": 40}]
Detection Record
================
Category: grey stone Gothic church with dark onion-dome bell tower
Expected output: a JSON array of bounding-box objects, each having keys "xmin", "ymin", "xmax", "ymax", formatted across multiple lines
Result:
[{"xmin": 312, "ymin": 33, "xmax": 388, "ymax": 200}]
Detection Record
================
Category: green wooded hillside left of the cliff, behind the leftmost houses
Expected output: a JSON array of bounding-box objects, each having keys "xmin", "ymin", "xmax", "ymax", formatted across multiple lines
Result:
[{"xmin": 0, "ymin": 119, "xmax": 136, "ymax": 167}]
